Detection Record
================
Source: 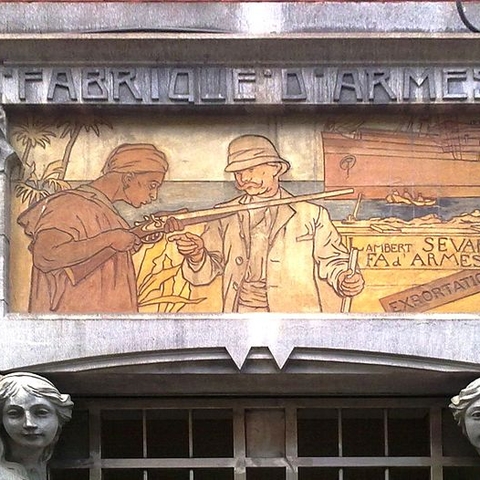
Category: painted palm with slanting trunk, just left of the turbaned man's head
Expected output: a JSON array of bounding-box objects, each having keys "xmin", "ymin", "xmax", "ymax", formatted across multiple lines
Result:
[{"xmin": 57, "ymin": 112, "xmax": 113, "ymax": 180}]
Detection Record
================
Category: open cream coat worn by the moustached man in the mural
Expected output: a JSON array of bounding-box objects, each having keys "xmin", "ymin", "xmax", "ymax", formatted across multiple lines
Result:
[{"xmin": 182, "ymin": 189, "xmax": 348, "ymax": 312}]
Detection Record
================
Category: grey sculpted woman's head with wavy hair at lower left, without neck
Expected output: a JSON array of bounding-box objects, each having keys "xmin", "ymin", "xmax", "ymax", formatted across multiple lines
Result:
[{"xmin": 0, "ymin": 372, "xmax": 73, "ymax": 462}]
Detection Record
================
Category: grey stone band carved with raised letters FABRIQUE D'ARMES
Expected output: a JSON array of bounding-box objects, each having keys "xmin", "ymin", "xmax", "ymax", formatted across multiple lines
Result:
[{"xmin": 5, "ymin": 62, "xmax": 480, "ymax": 108}]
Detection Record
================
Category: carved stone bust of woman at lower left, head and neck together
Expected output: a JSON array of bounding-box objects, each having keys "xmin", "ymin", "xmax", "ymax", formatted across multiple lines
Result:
[{"xmin": 0, "ymin": 372, "xmax": 73, "ymax": 480}]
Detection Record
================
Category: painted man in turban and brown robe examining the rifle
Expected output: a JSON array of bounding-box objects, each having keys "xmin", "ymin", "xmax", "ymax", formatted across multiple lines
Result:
[{"xmin": 18, "ymin": 144, "xmax": 168, "ymax": 313}]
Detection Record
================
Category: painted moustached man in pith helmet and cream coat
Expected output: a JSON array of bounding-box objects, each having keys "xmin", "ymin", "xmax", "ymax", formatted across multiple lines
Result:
[{"xmin": 171, "ymin": 135, "xmax": 363, "ymax": 313}]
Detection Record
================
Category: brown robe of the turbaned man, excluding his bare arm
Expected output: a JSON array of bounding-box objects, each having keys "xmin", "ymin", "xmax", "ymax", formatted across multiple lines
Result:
[{"xmin": 18, "ymin": 186, "xmax": 138, "ymax": 313}]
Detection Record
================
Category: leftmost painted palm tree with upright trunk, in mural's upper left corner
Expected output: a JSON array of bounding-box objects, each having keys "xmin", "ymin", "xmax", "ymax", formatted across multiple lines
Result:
[{"xmin": 12, "ymin": 115, "xmax": 57, "ymax": 181}]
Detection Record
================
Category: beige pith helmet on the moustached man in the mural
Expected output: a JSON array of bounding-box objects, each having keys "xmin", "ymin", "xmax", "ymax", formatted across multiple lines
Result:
[{"xmin": 225, "ymin": 135, "xmax": 290, "ymax": 175}]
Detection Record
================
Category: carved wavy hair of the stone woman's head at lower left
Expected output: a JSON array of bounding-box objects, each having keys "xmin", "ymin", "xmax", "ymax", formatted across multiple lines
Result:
[{"xmin": 0, "ymin": 372, "xmax": 73, "ymax": 461}]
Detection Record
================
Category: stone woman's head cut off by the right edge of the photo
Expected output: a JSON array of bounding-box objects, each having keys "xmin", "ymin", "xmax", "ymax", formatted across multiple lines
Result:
[{"xmin": 450, "ymin": 378, "xmax": 480, "ymax": 453}]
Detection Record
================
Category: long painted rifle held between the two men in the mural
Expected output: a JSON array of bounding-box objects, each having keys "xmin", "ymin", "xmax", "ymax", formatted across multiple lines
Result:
[{"xmin": 65, "ymin": 188, "xmax": 353, "ymax": 285}]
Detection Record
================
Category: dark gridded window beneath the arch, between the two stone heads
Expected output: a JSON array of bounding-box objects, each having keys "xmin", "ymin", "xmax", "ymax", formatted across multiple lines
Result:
[{"xmin": 47, "ymin": 399, "xmax": 480, "ymax": 480}]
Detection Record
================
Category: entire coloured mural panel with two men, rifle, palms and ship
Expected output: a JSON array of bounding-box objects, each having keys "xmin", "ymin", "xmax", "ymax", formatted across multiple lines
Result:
[{"xmin": 11, "ymin": 111, "xmax": 480, "ymax": 313}]
